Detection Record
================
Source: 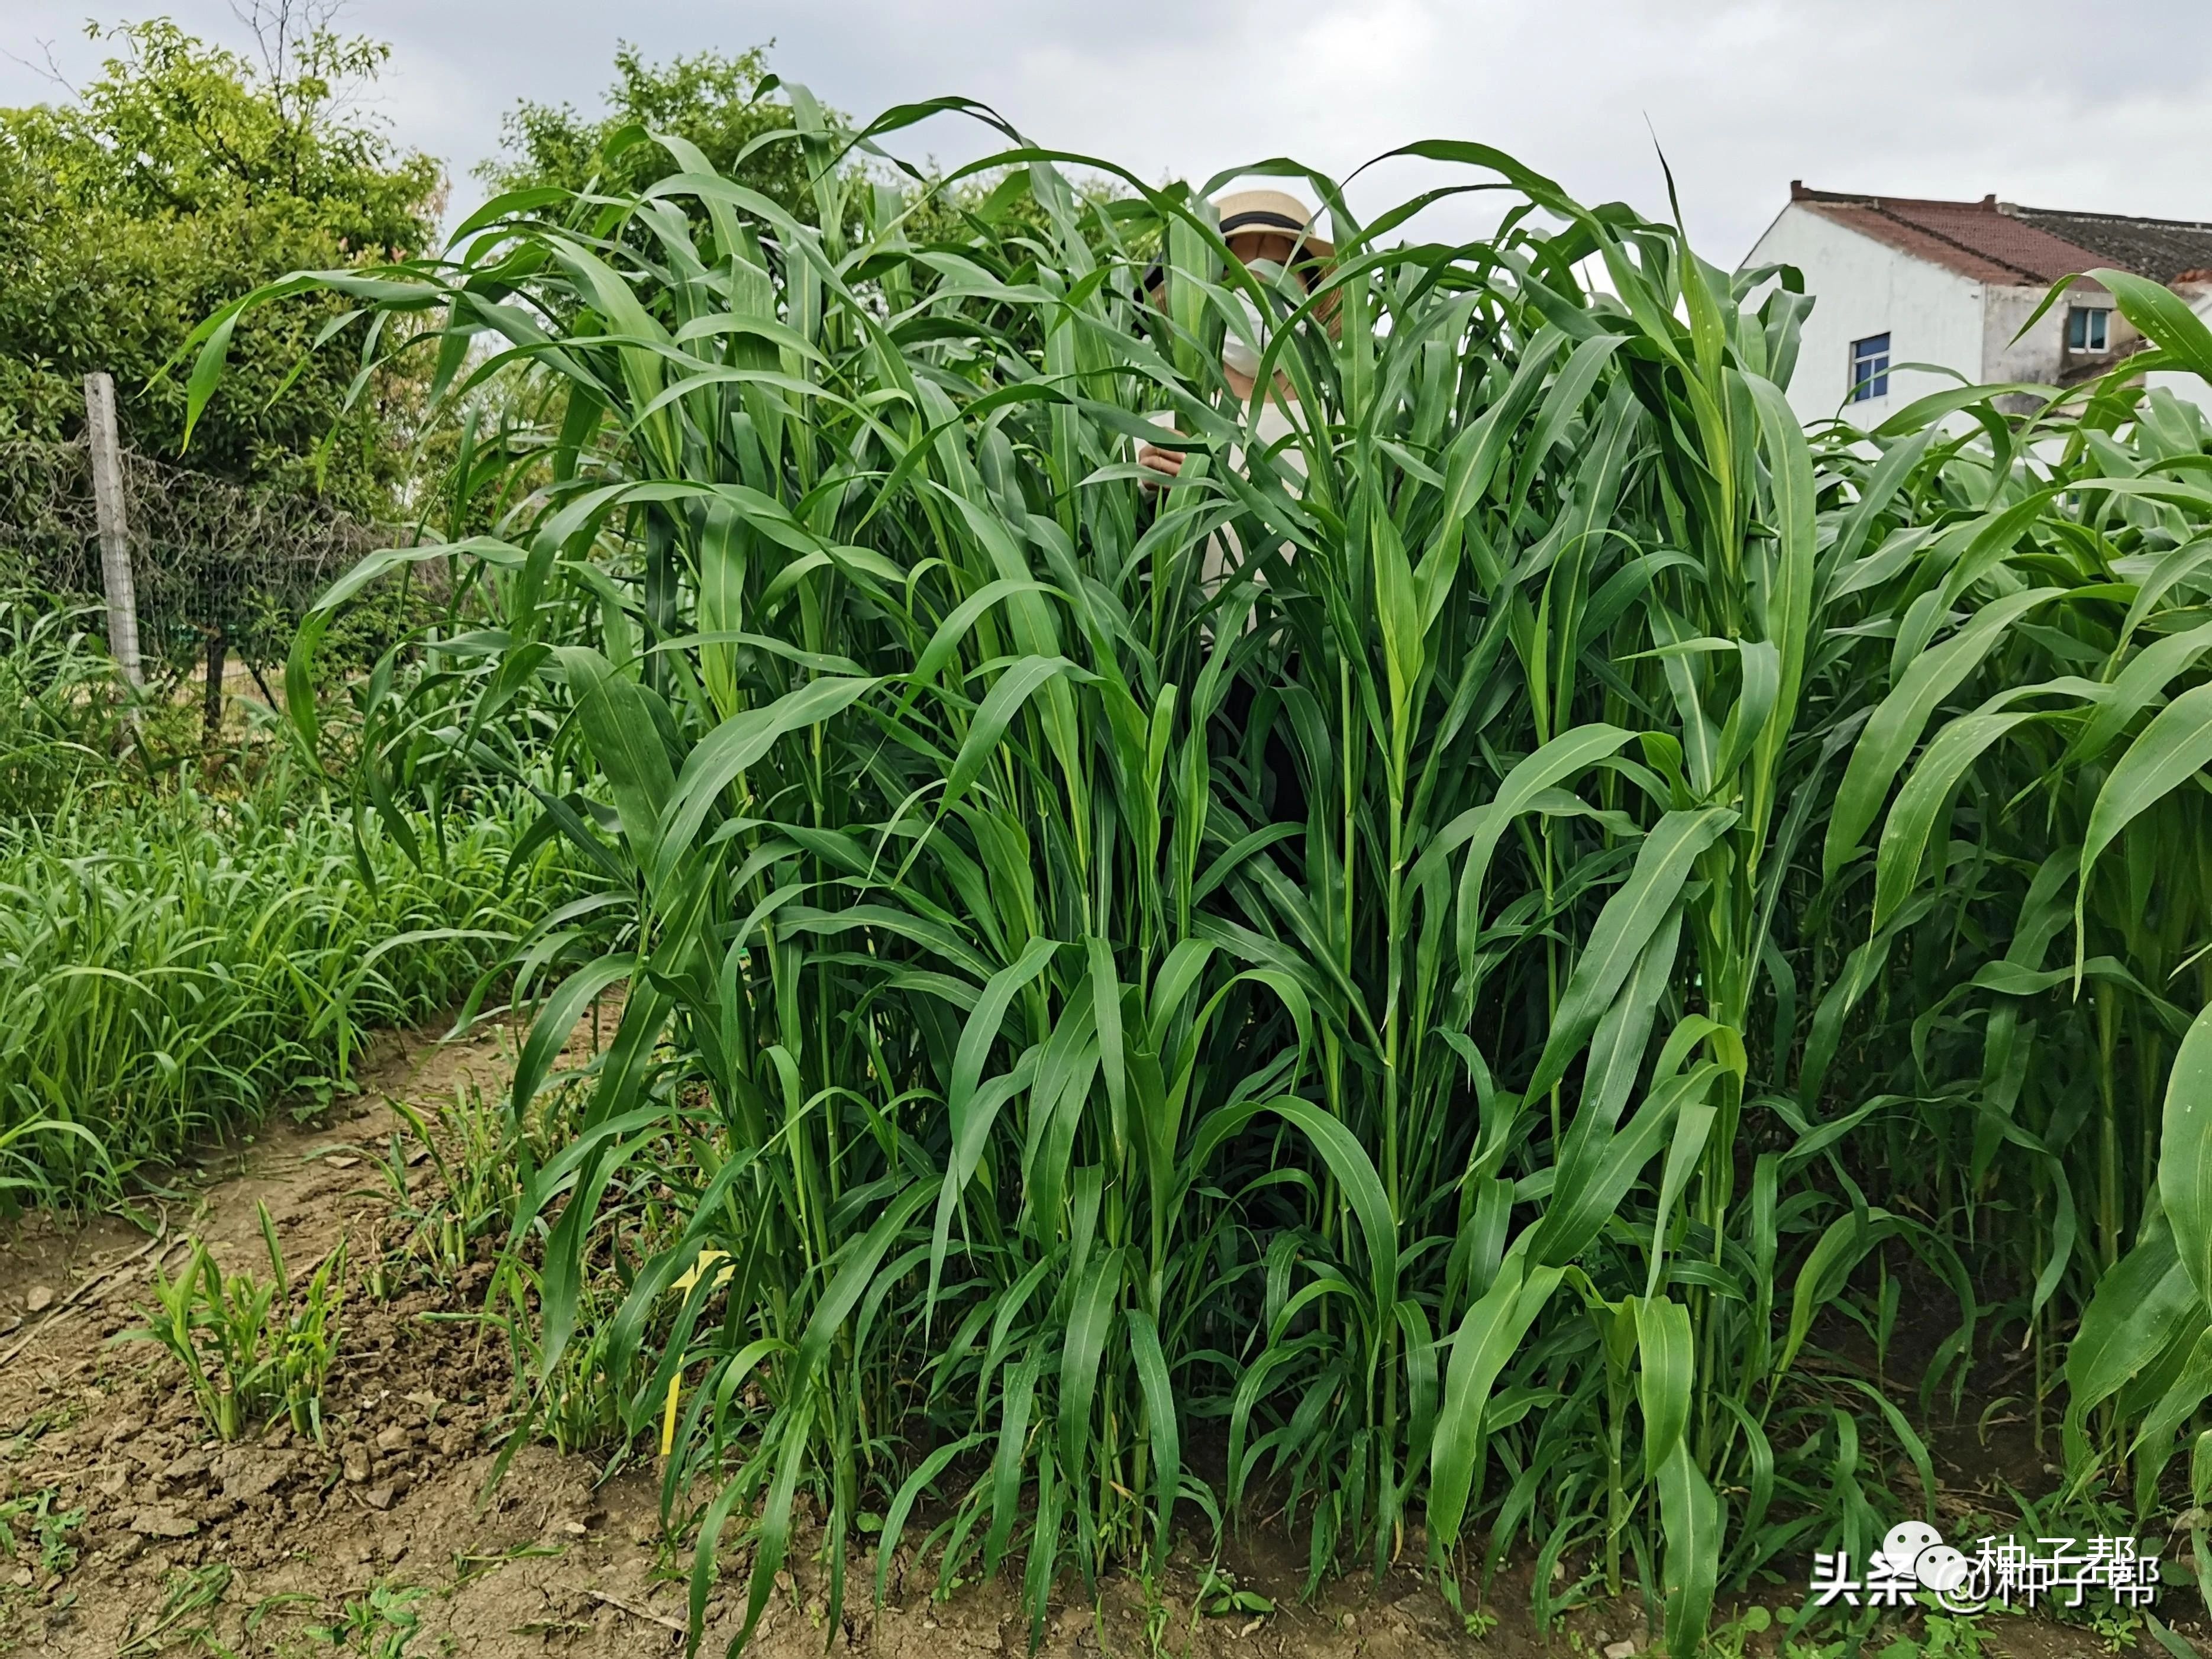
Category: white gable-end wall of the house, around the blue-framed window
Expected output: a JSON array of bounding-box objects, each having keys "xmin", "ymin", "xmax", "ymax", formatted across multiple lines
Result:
[{"xmin": 1743, "ymin": 201, "xmax": 1991, "ymax": 427}]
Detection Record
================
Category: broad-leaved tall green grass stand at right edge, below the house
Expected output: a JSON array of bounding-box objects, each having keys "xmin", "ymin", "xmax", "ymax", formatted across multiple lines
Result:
[{"xmin": 1801, "ymin": 272, "xmax": 2212, "ymax": 1519}]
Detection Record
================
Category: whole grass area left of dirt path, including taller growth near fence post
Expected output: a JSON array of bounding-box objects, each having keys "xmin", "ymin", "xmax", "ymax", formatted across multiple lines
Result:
[{"xmin": 0, "ymin": 573, "xmax": 566, "ymax": 1208}]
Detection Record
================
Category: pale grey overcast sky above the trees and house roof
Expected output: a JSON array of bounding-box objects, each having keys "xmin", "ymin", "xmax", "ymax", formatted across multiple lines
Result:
[{"xmin": 0, "ymin": 0, "xmax": 2212, "ymax": 263}]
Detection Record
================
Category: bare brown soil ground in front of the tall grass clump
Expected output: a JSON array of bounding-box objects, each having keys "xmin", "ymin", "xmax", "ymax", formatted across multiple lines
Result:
[{"xmin": 0, "ymin": 1028, "xmax": 2177, "ymax": 1659}]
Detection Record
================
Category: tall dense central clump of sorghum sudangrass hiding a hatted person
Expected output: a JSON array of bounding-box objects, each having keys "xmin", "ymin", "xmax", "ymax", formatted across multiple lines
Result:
[{"xmin": 195, "ymin": 106, "xmax": 2212, "ymax": 1655}]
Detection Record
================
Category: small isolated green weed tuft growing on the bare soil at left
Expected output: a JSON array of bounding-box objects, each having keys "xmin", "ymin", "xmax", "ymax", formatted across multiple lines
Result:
[{"xmin": 117, "ymin": 1206, "xmax": 345, "ymax": 1440}]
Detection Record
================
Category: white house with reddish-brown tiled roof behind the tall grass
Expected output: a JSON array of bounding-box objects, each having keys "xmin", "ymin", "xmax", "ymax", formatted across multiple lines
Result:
[{"xmin": 1745, "ymin": 182, "xmax": 2212, "ymax": 427}]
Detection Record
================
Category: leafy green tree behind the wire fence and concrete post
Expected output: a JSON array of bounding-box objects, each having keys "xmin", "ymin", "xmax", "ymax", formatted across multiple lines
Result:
[{"xmin": 0, "ymin": 0, "xmax": 445, "ymax": 710}]
